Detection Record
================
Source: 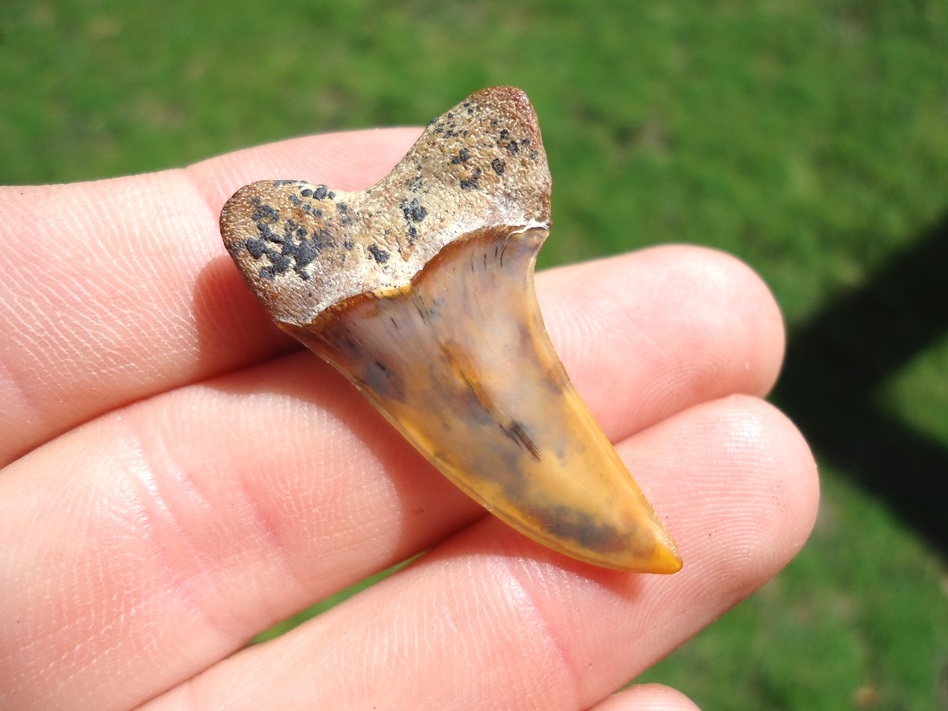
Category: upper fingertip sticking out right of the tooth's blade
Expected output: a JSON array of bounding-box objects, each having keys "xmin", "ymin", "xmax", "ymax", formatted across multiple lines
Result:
[{"xmin": 538, "ymin": 245, "xmax": 784, "ymax": 440}]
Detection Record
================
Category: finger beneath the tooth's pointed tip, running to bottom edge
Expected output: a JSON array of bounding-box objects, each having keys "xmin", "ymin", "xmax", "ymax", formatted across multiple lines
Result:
[{"xmin": 149, "ymin": 396, "xmax": 817, "ymax": 709}]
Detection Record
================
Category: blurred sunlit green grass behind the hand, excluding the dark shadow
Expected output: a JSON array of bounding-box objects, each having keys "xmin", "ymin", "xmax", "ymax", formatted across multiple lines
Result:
[{"xmin": 0, "ymin": 0, "xmax": 948, "ymax": 710}]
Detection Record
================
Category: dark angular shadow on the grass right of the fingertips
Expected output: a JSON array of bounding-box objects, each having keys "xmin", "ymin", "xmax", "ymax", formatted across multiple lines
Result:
[{"xmin": 773, "ymin": 214, "xmax": 948, "ymax": 556}]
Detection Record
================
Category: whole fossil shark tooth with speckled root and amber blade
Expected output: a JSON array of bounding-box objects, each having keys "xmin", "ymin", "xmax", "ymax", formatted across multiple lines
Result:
[{"xmin": 221, "ymin": 87, "xmax": 681, "ymax": 573}]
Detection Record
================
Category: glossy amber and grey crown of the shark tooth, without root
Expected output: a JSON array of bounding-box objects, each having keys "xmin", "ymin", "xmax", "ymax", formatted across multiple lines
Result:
[{"xmin": 290, "ymin": 229, "xmax": 681, "ymax": 573}]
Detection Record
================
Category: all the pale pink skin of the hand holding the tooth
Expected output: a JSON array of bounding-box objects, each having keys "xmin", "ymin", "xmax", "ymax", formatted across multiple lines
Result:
[{"xmin": 0, "ymin": 129, "xmax": 818, "ymax": 711}]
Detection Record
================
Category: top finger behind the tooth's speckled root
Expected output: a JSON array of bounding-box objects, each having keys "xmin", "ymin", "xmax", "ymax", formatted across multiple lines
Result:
[{"xmin": 0, "ymin": 129, "xmax": 418, "ymax": 465}]
